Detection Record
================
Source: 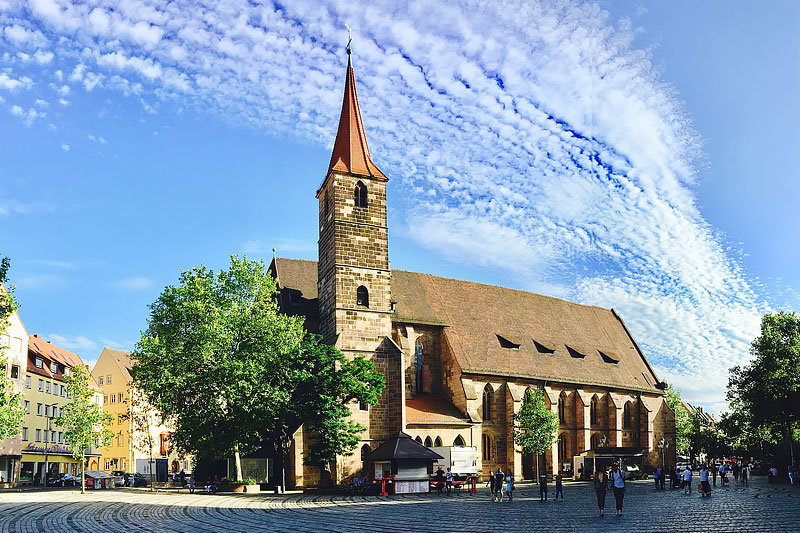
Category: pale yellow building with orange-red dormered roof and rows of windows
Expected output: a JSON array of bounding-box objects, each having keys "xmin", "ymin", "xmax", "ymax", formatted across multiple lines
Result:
[{"xmin": 20, "ymin": 335, "xmax": 102, "ymax": 485}]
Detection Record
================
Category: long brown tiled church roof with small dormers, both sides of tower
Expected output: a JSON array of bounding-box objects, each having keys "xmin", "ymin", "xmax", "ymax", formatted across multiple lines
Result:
[{"xmin": 272, "ymin": 258, "xmax": 662, "ymax": 393}]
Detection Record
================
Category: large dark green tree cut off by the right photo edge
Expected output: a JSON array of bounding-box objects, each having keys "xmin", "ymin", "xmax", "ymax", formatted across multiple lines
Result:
[{"xmin": 727, "ymin": 312, "xmax": 800, "ymax": 462}]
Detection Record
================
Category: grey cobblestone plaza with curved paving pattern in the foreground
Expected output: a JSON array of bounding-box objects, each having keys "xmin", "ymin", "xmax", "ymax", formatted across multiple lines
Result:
[{"xmin": 0, "ymin": 478, "xmax": 800, "ymax": 533}]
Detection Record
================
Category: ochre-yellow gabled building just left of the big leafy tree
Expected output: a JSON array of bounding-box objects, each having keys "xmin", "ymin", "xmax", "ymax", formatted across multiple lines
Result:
[{"xmin": 92, "ymin": 348, "xmax": 191, "ymax": 482}]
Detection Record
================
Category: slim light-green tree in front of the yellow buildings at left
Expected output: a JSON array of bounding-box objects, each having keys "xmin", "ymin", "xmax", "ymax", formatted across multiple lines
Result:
[{"xmin": 56, "ymin": 365, "xmax": 114, "ymax": 494}]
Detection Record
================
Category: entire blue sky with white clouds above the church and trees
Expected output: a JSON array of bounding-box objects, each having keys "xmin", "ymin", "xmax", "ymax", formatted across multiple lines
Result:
[{"xmin": 0, "ymin": 0, "xmax": 800, "ymax": 410}]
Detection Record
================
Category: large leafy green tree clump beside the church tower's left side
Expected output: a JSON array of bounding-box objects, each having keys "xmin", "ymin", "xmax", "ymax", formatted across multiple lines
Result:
[{"xmin": 132, "ymin": 256, "xmax": 384, "ymax": 484}]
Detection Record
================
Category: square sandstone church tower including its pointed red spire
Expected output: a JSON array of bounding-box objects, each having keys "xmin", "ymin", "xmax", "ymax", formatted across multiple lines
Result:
[{"xmin": 317, "ymin": 47, "xmax": 401, "ymax": 475}]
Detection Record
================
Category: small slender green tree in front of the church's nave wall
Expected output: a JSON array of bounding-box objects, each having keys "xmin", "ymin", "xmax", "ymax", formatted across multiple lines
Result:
[{"xmin": 512, "ymin": 389, "xmax": 558, "ymax": 477}]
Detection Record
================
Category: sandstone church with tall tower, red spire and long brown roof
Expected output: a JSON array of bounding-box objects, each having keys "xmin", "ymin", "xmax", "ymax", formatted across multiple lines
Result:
[{"xmin": 270, "ymin": 48, "xmax": 675, "ymax": 487}]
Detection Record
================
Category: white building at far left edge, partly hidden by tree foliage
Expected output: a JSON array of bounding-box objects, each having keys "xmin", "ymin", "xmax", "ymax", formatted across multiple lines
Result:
[{"xmin": 0, "ymin": 283, "xmax": 28, "ymax": 487}]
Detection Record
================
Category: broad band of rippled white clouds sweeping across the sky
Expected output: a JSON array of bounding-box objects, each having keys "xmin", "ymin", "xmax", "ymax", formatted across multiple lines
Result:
[{"xmin": 0, "ymin": 0, "xmax": 765, "ymax": 408}]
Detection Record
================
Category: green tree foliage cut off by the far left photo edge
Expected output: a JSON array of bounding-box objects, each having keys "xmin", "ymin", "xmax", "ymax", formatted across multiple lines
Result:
[{"xmin": 0, "ymin": 257, "xmax": 25, "ymax": 440}]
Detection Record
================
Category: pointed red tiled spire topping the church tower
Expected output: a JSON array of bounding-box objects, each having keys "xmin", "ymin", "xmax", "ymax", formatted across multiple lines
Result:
[{"xmin": 328, "ymin": 52, "xmax": 389, "ymax": 180}]
